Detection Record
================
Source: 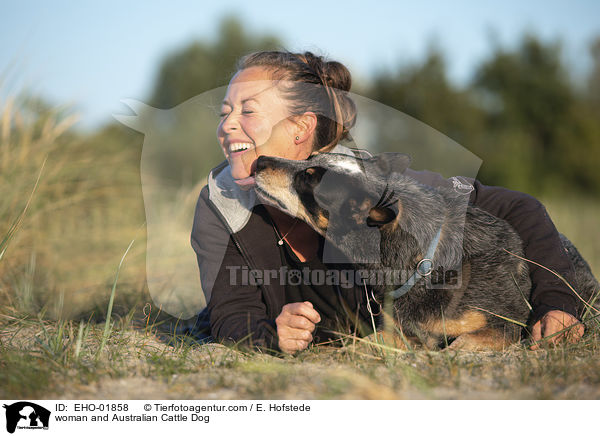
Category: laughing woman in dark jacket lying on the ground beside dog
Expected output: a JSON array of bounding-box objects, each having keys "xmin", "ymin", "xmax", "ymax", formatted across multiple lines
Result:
[{"xmin": 192, "ymin": 52, "xmax": 583, "ymax": 353}]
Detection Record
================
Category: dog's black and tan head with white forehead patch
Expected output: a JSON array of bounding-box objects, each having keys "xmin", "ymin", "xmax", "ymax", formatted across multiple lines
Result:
[{"xmin": 255, "ymin": 153, "xmax": 410, "ymax": 263}]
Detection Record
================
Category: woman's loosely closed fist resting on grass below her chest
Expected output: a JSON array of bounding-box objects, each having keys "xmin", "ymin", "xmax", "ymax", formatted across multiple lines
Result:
[{"xmin": 275, "ymin": 301, "xmax": 321, "ymax": 354}]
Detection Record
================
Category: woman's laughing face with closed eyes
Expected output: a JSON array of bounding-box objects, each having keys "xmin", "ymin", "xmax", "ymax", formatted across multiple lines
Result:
[{"xmin": 217, "ymin": 67, "xmax": 310, "ymax": 186}]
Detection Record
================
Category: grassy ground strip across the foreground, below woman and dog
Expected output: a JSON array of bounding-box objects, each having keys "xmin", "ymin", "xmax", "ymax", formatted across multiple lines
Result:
[{"xmin": 0, "ymin": 315, "xmax": 600, "ymax": 399}]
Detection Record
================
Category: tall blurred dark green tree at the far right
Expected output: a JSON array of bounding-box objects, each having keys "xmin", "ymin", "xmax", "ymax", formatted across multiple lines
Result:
[{"xmin": 473, "ymin": 35, "xmax": 600, "ymax": 194}]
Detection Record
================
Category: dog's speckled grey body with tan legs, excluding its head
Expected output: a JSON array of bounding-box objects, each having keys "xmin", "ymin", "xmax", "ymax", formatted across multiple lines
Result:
[{"xmin": 380, "ymin": 176, "xmax": 600, "ymax": 349}]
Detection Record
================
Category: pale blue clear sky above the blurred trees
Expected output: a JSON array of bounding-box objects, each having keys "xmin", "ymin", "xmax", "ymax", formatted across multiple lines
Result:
[{"xmin": 0, "ymin": 0, "xmax": 600, "ymax": 129}]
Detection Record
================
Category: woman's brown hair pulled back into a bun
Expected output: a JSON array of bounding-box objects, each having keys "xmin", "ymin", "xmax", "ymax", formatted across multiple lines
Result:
[{"xmin": 237, "ymin": 51, "xmax": 356, "ymax": 152}]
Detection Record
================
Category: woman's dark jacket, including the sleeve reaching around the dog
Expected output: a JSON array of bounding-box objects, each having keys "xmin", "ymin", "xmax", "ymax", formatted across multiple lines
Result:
[{"xmin": 191, "ymin": 153, "xmax": 578, "ymax": 350}]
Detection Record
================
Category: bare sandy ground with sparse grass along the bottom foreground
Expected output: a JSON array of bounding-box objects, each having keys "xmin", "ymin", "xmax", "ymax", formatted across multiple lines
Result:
[{"xmin": 0, "ymin": 327, "xmax": 600, "ymax": 400}]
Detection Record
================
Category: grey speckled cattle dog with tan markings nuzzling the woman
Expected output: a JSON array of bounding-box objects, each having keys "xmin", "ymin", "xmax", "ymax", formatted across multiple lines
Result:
[{"xmin": 255, "ymin": 153, "xmax": 600, "ymax": 350}]
